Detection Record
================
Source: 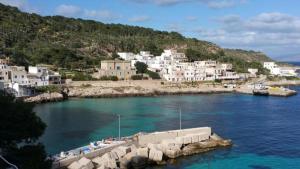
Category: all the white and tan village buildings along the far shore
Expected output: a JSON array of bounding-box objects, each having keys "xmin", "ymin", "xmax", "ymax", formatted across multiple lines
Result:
[{"xmin": 0, "ymin": 49, "xmax": 299, "ymax": 97}]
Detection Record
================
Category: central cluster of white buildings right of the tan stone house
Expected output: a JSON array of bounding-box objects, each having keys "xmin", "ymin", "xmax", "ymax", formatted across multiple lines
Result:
[{"xmin": 118, "ymin": 49, "xmax": 239, "ymax": 82}]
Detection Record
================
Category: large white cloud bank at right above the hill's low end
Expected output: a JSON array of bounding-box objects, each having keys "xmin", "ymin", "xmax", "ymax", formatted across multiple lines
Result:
[{"xmin": 197, "ymin": 13, "xmax": 300, "ymax": 55}]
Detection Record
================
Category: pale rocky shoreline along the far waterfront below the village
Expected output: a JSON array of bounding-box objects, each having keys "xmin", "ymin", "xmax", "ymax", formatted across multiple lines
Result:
[{"xmin": 24, "ymin": 80, "xmax": 300, "ymax": 104}]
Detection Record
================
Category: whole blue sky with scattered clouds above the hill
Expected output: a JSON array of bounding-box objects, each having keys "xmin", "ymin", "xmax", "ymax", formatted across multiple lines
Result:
[{"xmin": 0, "ymin": 0, "xmax": 300, "ymax": 61}]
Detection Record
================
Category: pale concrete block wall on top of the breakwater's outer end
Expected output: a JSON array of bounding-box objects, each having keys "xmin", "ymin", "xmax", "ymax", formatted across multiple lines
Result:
[{"xmin": 138, "ymin": 127, "xmax": 212, "ymax": 146}]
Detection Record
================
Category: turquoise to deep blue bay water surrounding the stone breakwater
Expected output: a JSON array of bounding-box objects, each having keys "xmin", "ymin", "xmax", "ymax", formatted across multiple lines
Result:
[{"xmin": 35, "ymin": 87, "xmax": 300, "ymax": 169}]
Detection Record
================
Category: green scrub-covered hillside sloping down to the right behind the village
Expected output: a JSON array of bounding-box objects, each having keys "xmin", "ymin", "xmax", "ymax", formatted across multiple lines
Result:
[{"xmin": 0, "ymin": 4, "xmax": 268, "ymax": 72}]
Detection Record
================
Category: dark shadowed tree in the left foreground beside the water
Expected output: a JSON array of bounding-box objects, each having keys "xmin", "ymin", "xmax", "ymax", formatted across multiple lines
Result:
[{"xmin": 0, "ymin": 90, "xmax": 52, "ymax": 169}]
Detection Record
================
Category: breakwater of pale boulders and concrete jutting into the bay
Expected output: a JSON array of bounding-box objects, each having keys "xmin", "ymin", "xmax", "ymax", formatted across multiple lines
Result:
[{"xmin": 54, "ymin": 127, "xmax": 231, "ymax": 169}]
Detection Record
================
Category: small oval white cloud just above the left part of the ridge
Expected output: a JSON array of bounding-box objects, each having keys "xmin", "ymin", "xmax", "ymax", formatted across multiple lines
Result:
[{"xmin": 55, "ymin": 4, "xmax": 82, "ymax": 17}]
